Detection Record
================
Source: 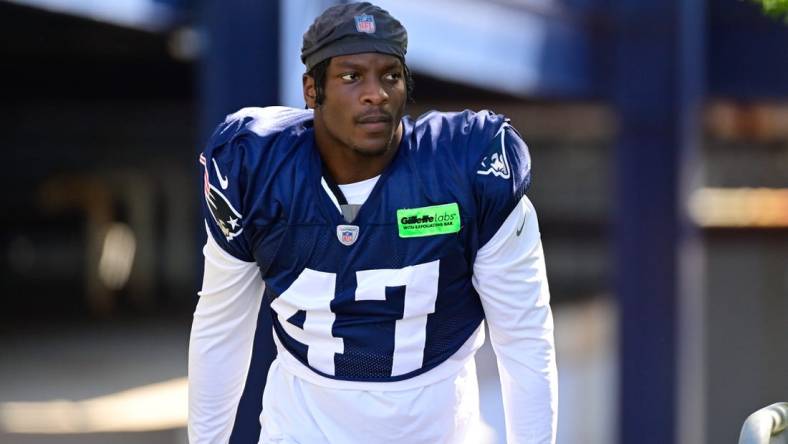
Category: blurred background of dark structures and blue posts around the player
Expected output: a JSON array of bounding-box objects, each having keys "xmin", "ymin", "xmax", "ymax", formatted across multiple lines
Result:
[{"xmin": 0, "ymin": 0, "xmax": 788, "ymax": 444}]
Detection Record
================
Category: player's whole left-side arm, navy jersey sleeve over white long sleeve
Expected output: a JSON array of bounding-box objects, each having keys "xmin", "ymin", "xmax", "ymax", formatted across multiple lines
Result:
[{"xmin": 189, "ymin": 127, "xmax": 264, "ymax": 444}]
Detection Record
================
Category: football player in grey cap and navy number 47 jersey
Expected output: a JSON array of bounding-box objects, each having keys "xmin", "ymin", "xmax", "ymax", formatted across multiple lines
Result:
[{"xmin": 189, "ymin": 3, "xmax": 557, "ymax": 444}]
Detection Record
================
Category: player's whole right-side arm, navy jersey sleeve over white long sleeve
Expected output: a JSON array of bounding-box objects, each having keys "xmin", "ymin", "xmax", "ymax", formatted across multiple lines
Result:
[{"xmin": 473, "ymin": 120, "xmax": 558, "ymax": 444}]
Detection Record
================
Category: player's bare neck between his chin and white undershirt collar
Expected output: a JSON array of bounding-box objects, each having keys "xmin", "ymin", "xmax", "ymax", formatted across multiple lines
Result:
[{"xmin": 315, "ymin": 122, "xmax": 403, "ymax": 185}]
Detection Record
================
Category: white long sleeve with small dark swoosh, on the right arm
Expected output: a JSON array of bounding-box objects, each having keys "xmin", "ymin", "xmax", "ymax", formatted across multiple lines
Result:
[{"xmin": 473, "ymin": 196, "xmax": 558, "ymax": 444}]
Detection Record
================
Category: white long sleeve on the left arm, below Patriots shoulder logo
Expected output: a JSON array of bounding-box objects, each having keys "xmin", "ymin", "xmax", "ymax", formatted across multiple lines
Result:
[{"xmin": 188, "ymin": 232, "xmax": 265, "ymax": 444}]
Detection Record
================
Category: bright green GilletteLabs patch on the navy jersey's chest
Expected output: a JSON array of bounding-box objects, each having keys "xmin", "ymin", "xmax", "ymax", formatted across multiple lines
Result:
[{"xmin": 397, "ymin": 203, "xmax": 460, "ymax": 237}]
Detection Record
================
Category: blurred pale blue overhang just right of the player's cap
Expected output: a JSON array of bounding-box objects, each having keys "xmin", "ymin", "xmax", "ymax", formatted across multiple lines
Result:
[{"xmin": 376, "ymin": 0, "xmax": 603, "ymax": 97}]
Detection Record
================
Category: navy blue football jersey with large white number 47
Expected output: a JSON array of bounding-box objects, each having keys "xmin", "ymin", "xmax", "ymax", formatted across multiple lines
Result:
[{"xmin": 200, "ymin": 107, "xmax": 530, "ymax": 381}]
